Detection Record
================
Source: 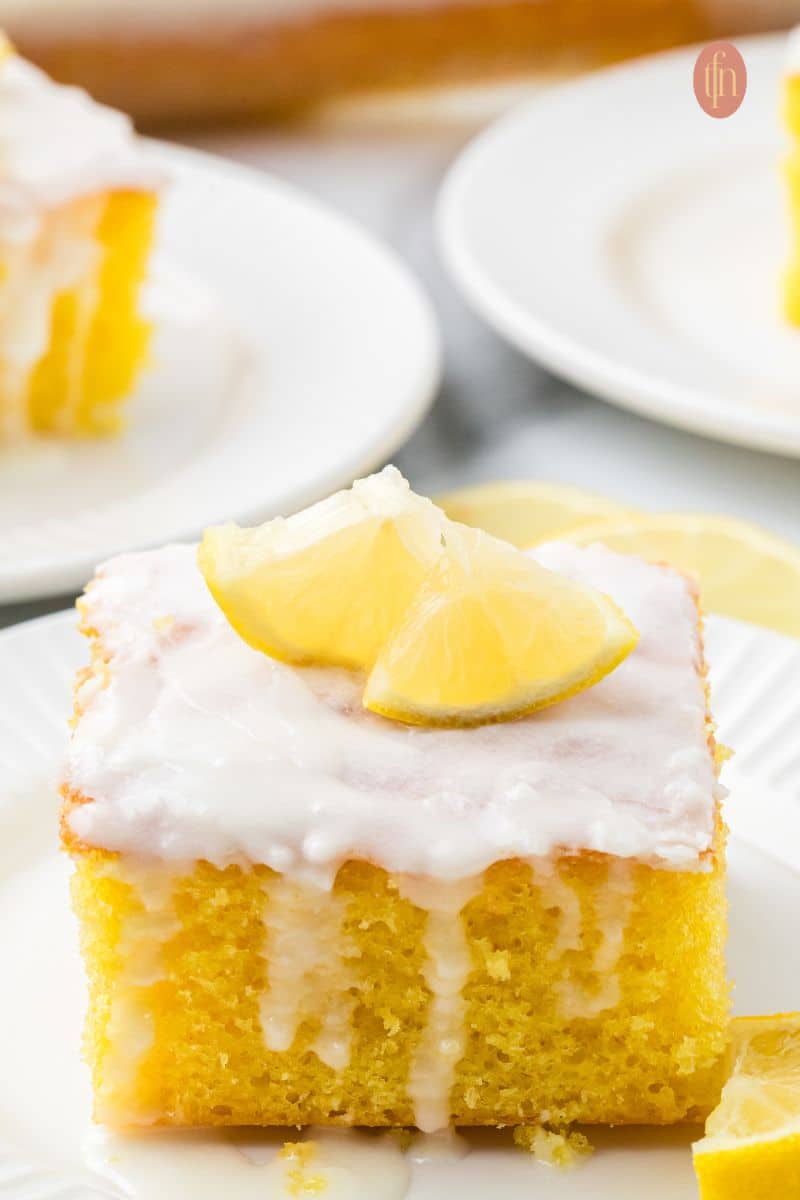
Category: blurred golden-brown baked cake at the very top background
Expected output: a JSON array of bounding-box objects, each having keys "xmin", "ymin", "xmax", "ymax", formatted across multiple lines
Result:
[{"xmin": 6, "ymin": 0, "xmax": 800, "ymax": 121}]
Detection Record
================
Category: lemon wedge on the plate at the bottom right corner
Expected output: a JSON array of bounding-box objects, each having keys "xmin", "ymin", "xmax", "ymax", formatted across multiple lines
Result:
[{"xmin": 693, "ymin": 1013, "xmax": 800, "ymax": 1200}]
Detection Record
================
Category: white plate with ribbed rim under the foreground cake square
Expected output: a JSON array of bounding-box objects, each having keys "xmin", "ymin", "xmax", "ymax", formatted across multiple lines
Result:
[{"xmin": 0, "ymin": 614, "xmax": 800, "ymax": 1200}]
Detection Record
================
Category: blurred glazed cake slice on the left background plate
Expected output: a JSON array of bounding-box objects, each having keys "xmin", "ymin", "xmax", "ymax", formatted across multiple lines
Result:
[{"xmin": 0, "ymin": 37, "xmax": 160, "ymax": 437}]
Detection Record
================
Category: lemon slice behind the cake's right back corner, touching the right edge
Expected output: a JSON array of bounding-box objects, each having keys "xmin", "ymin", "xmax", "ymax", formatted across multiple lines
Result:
[{"xmin": 564, "ymin": 512, "xmax": 800, "ymax": 637}]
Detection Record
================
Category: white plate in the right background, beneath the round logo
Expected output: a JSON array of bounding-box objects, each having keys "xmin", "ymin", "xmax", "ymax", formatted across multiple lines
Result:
[{"xmin": 439, "ymin": 37, "xmax": 800, "ymax": 455}]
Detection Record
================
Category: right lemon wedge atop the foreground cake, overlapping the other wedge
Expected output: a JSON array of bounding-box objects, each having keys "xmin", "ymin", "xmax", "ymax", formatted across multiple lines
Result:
[{"xmin": 363, "ymin": 526, "xmax": 638, "ymax": 726}]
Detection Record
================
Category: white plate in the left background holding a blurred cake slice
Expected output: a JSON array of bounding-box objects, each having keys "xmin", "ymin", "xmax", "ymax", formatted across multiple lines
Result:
[{"xmin": 0, "ymin": 143, "xmax": 439, "ymax": 602}]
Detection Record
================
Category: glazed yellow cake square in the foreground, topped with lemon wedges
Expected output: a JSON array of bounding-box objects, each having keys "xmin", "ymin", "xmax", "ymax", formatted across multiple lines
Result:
[{"xmin": 62, "ymin": 479, "xmax": 728, "ymax": 1130}]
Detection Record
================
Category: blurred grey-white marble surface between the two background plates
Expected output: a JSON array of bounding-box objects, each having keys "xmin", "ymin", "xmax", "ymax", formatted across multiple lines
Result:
[{"xmin": 0, "ymin": 87, "xmax": 800, "ymax": 625}]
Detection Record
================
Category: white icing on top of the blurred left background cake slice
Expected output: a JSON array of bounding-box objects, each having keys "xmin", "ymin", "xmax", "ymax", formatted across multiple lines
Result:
[{"xmin": 0, "ymin": 55, "xmax": 163, "ymax": 225}]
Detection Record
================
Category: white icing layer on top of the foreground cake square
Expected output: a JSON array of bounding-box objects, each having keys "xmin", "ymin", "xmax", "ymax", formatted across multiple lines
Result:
[{"xmin": 66, "ymin": 545, "xmax": 718, "ymax": 881}]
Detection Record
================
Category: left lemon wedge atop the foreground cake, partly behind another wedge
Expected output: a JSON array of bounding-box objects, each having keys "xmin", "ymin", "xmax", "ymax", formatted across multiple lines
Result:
[{"xmin": 198, "ymin": 467, "xmax": 446, "ymax": 668}]
